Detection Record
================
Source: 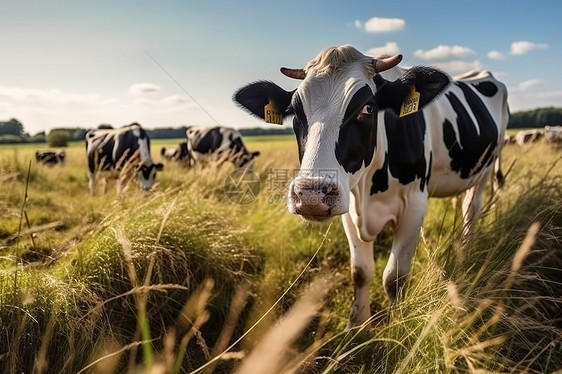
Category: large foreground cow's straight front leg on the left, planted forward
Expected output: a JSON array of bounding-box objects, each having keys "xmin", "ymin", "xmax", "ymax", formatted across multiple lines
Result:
[{"xmin": 342, "ymin": 214, "xmax": 375, "ymax": 329}]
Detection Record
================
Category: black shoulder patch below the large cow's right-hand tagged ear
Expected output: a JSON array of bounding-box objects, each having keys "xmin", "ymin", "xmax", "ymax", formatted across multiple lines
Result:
[{"xmin": 384, "ymin": 109, "xmax": 427, "ymax": 191}]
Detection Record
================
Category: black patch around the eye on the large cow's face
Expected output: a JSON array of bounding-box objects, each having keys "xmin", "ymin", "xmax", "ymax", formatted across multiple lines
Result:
[{"xmin": 336, "ymin": 85, "xmax": 377, "ymax": 173}]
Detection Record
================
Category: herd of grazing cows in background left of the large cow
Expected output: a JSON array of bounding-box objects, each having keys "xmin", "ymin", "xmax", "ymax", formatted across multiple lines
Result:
[{"xmin": 35, "ymin": 123, "xmax": 259, "ymax": 195}]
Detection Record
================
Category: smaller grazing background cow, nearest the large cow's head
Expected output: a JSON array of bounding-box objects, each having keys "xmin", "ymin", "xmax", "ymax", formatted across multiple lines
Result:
[{"xmin": 186, "ymin": 126, "xmax": 260, "ymax": 169}]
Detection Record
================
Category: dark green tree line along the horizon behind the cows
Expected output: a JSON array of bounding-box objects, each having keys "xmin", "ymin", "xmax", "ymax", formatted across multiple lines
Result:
[{"xmin": 0, "ymin": 107, "xmax": 562, "ymax": 147}]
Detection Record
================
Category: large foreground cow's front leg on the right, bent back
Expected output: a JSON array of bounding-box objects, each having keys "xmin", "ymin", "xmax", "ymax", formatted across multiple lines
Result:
[{"xmin": 382, "ymin": 195, "xmax": 427, "ymax": 302}]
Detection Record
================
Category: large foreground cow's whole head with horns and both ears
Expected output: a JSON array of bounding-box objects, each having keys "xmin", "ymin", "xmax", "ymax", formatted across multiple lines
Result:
[{"xmin": 234, "ymin": 46, "xmax": 449, "ymax": 221}]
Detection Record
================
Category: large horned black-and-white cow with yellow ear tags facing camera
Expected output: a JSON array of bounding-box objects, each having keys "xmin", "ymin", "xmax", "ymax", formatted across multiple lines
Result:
[{"xmin": 234, "ymin": 46, "xmax": 509, "ymax": 327}]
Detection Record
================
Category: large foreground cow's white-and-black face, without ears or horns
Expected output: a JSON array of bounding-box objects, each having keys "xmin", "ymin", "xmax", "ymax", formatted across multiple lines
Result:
[{"xmin": 288, "ymin": 59, "xmax": 384, "ymax": 221}]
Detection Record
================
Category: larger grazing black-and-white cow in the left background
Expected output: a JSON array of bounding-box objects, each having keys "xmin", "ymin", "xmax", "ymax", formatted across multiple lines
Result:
[{"xmin": 86, "ymin": 123, "xmax": 163, "ymax": 195}]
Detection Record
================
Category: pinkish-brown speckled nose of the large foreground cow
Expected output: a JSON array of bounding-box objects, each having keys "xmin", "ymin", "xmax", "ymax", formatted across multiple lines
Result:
[{"xmin": 290, "ymin": 178, "xmax": 340, "ymax": 219}]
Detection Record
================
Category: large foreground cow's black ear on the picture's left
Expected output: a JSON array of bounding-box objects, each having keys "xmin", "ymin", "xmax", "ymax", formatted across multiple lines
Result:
[{"xmin": 233, "ymin": 81, "xmax": 294, "ymax": 120}]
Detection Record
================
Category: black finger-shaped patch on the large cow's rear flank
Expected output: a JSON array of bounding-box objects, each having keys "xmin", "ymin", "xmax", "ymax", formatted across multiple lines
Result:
[{"xmin": 443, "ymin": 82, "xmax": 498, "ymax": 179}]
